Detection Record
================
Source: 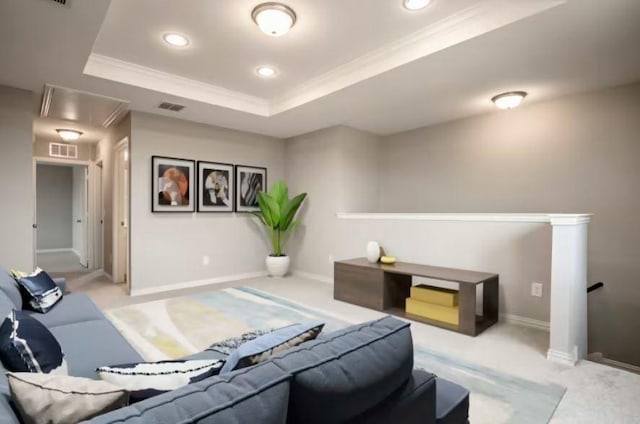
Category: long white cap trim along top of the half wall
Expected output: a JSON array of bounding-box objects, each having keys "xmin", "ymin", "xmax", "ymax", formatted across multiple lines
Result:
[{"xmin": 336, "ymin": 212, "xmax": 592, "ymax": 224}]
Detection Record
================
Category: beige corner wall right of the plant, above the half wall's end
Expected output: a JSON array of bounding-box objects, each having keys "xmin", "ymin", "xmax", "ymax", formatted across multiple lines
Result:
[{"xmin": 285, "ymin": 127, "xmax": 380, "ymax": 277}]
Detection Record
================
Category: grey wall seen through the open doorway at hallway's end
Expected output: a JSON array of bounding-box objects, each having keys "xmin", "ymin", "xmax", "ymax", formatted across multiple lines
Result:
[{"xmin": 36, "ymin": 164, "xmax": 73, "ymax": 250}]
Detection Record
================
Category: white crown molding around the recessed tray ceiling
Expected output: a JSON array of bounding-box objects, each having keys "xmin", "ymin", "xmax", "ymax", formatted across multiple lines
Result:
[{"xmin": 84, "ymin": 0, "xmax": 567, "ymax": 117}]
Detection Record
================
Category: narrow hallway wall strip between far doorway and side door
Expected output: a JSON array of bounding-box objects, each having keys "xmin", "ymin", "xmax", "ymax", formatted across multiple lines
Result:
[{"xmin": 94, "ymin": 115, "xmax": 131, "ymax": 275}]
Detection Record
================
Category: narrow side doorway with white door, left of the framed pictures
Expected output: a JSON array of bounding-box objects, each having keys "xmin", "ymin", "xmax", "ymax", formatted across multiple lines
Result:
[{"xmin": 113, "ymin": 137, "xmax": 131, "ymax": 291}]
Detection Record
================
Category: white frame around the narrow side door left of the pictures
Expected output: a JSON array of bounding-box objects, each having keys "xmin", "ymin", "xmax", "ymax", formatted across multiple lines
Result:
[{"xmin": 111, "ymin": 137, "xmax": 131, "ymax": 293}]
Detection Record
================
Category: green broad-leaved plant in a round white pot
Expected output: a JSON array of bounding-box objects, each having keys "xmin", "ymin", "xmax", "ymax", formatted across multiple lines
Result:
[{"xmin": 253, "ymin": 181, "xmax": 307, "ymax": 277}]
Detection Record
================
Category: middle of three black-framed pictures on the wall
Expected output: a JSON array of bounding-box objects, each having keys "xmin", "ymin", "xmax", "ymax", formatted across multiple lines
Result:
[{"xmin": 197, "ymin": 161, "xmax": 236, "ymax": 213}]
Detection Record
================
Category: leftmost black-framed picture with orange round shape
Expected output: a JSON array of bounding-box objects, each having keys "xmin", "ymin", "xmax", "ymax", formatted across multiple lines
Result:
[{"xmin": 151, "ymin": 156, "xmax": 196, "ymax": 213}]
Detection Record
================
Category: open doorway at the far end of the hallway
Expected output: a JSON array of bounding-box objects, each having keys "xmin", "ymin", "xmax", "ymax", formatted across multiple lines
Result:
[{"xmin": 34, "ymin": 160, "xmax": 91, "ymax": 273}]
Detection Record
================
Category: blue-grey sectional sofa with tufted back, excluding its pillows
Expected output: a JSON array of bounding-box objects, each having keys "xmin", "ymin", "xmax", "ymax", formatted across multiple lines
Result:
[{"xmin": 0, "ymin": 270, "xmax": 469, "ymax": 424}]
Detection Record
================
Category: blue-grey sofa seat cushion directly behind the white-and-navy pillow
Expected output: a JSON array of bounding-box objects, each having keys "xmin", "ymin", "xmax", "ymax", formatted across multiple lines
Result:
[{"xmin": 51, "ymin": 320, "xmax": 142, "ymax": 378}]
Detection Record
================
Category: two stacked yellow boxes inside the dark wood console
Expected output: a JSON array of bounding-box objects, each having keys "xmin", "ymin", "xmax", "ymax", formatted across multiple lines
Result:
[{"xmin": 406, "ymin": 285, "xmax": 459, "ymax": 325}]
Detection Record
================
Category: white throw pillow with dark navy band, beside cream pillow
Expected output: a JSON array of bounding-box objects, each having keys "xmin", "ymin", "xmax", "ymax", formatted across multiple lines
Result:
[{"xmin": 96, "ymin": 359, "xmax": 224, "ymax": 403}]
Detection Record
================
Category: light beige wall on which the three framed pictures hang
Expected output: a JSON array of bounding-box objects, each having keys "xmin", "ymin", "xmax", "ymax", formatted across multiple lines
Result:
[{"xmin": 130, "ymin": 112, "xmax": 284, "ymax": 293}]
